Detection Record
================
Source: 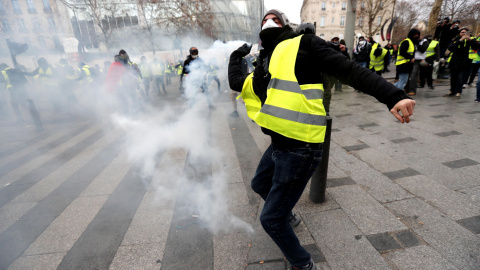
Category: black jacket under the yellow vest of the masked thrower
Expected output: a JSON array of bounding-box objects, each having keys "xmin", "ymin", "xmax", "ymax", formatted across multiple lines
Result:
[{"xmin": 228, "ymin": 26, "xmax": 409, "ymax": 147}]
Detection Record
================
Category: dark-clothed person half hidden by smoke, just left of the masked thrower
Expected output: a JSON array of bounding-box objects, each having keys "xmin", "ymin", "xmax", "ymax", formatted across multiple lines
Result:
[{"xmin": 180, "ymin": 47, "xmax": 214, "ymax": 109}]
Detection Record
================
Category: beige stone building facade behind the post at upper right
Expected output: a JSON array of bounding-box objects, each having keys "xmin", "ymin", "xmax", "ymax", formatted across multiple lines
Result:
[{"xmin": 300, "ymin": 0, "xmax": 393, "ymax": 45}]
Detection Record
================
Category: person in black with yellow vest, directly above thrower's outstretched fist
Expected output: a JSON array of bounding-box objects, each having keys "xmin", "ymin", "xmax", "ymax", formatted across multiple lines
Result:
[{"xmin": 395, "ymin": 28, "xmax": 420, "ymax": 89}]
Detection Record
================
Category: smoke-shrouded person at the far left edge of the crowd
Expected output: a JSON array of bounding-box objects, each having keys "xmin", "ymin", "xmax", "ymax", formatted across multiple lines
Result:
[{"xmin": 0, "ymin": 63, "xmax": 30, "ymax": 127}]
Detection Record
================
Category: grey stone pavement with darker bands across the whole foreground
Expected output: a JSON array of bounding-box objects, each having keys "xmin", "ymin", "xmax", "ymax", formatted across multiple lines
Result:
[{"xmin": 0, "ymin": 74, "xmax": 480, "ymax": 270}]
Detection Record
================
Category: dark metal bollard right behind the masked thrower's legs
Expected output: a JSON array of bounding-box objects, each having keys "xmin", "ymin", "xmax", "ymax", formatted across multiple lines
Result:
[{"xmin": 309, "ymin": 116, "xmax": 332, "ymax": 203}]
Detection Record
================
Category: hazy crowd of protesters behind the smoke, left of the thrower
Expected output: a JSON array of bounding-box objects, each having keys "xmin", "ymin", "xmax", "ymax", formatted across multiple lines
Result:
[{"xmin": 0, "ymin": 48, "xmax": 231, "ymax": 127}]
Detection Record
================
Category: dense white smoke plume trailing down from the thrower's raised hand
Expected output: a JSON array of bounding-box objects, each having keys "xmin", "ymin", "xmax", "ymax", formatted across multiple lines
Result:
[{"xmin": 112, "ymin": 41, "xmax": 253, "ymax": 234}]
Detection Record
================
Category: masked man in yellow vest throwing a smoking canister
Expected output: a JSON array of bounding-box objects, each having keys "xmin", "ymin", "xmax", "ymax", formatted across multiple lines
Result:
[{"xmin": 228, "ymin": 10, "xmax": 415, "ymax": 270}]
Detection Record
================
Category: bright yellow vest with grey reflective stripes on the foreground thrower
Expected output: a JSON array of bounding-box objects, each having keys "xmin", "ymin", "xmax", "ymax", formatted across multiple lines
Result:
[{"xmin": 254, "ymin": 36, "xmax": 326, "ymax": 143}]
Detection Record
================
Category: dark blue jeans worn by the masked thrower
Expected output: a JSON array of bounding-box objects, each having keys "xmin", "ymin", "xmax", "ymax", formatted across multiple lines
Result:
[{"xmin": 252, "ymin": 143, "xmax": 322, "ymax": 267}]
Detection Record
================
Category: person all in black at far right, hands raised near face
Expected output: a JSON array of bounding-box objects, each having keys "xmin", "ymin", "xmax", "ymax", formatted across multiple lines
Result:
[{"xmin": 446, "ymin": 28, "xmax": 480, "ymax": 97}]
